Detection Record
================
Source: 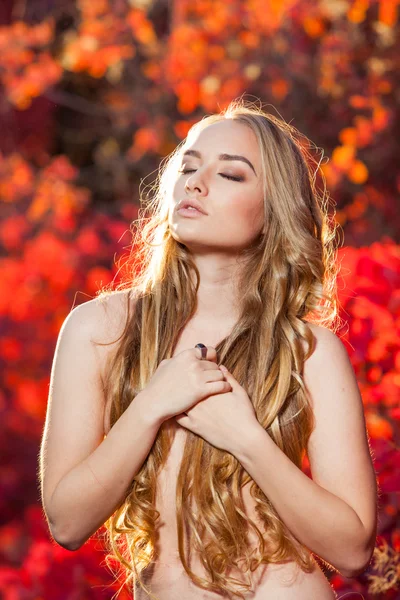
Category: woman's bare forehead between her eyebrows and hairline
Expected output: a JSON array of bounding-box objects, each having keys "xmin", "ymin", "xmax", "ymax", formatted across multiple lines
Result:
[{"xmin": 182, "ymin": 119, "xmax": 260, "ymax": 164}]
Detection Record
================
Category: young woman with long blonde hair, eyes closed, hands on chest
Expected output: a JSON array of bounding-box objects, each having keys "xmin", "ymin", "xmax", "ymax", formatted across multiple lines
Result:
[{"xmin": 40, "ymin": 100, "xmax": 377, "ymax": 600}]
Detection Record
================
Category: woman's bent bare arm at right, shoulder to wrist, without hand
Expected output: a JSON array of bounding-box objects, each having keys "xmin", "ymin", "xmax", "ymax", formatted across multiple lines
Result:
[{"xmin": 231, "ymin": 325, "xmax": 377, "ymax": 577}]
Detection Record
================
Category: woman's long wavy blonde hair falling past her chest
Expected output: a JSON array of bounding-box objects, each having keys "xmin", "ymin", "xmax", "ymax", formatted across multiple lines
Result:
[{"xmin": 96, "ymin": 98, "xmax": 338, "ymax": 600}]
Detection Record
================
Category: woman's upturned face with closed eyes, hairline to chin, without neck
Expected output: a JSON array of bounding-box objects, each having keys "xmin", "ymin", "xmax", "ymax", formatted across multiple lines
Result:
[{"xmin": 169, "ymin": 119, "xmax": 264, "ymax": 253}]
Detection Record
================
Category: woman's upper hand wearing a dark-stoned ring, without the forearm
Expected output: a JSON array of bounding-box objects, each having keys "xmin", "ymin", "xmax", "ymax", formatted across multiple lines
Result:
[{"xmin": 142, "ymin": 346, "xmax": 232, "ymax": 421}]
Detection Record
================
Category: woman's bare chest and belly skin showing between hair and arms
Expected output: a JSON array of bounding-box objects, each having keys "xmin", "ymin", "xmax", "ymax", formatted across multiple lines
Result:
[{"xmin": 104, "ymin": 300, "xmax": 337, "ymax": 600}]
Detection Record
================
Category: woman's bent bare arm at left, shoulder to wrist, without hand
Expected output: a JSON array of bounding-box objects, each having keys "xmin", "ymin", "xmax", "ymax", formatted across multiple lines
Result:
[{"xmin": 39, "ymin": 297, "xmax": 162, "ymax": 550}]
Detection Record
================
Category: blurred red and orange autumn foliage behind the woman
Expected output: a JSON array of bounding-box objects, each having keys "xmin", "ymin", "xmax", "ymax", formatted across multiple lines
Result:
[{"xmin": 0, "ymin": 0, "xmax": 400, "ymax": 600}]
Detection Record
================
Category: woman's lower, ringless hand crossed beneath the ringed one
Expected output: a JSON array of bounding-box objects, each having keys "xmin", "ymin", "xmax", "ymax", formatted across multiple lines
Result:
[{"xmin": 175, "ymin": 365, "xmax": 261, "ymax": 455}]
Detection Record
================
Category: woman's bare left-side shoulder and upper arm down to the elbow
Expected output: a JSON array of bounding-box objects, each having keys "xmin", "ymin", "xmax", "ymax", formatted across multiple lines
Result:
[{"xmin": 40, "ymin": 293, "xmax": 139, "ymax": 510}]
